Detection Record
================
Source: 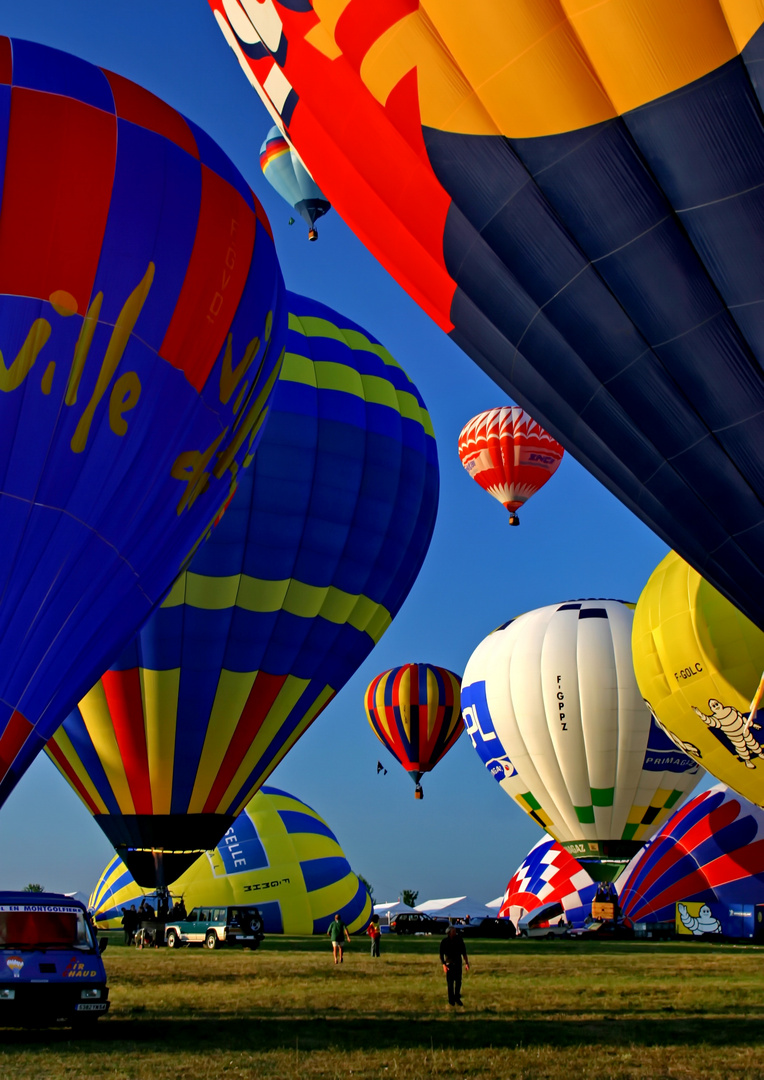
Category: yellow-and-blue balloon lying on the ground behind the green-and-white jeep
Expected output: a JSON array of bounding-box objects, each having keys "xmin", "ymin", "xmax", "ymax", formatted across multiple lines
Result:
[{"xmin": 89, "ymin": 785, "xmax": 372, "ymax": 934}]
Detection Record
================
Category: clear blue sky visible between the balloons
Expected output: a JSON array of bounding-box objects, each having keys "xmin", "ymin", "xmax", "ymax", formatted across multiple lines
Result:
[{"xmin": 0, "ymin": 0, "xmax": 695, "ymax": 902}]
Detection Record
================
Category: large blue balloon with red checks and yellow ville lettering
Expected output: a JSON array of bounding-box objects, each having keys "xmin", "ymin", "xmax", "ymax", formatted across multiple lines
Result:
[{"xmin": 0, "ymin": 38, "xmax": 286, "ymax": 804}]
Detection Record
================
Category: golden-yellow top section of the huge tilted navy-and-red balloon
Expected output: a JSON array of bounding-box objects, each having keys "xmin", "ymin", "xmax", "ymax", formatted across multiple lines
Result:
[{"xmin": 358, "ymin": 0, "xmax": 747, "ymax": 138}]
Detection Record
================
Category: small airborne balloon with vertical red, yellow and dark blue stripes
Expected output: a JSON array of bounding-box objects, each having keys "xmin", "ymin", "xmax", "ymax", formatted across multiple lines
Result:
[{"xmin": 364, "ymin": 664, "xmax": 461, "ymax": 799}]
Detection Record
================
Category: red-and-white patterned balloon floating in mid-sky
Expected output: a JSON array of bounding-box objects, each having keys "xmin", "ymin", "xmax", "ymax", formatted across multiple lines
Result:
[{"xmin": 459, "ymin": 405, "xmax": 565, "ymax": 525}]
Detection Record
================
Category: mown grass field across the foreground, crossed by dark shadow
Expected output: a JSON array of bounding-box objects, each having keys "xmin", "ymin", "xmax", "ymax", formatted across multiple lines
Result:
[{"xmin": 0, "ymin": 936, "xmax": 764, "ymax": 1080}]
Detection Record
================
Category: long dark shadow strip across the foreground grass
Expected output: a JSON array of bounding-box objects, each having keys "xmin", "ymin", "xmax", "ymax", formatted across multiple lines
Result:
[{"xmin": 2, "ymin": 1007, "xmax": 764, "ymax": 1055}]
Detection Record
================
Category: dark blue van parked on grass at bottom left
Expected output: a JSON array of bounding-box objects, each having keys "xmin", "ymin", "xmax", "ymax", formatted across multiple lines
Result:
[{"xmin": 0, "ymin": 892, "xmax": 109, "ymax": 1026}]
